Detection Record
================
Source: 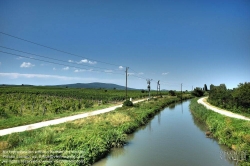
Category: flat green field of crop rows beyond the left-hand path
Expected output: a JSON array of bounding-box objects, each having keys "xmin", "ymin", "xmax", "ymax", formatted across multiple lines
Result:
[{"xmin": 0, "ymin": 86, "xmax": 172, "ymax": 129}]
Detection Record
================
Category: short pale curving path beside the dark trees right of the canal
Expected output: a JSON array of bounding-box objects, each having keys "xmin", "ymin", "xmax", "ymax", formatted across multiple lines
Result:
[{"xmin": 197, "ymin": 97, "xmax": 250, "ymax": 121}]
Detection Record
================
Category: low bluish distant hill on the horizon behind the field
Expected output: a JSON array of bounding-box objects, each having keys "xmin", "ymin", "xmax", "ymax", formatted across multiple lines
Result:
[{"xmin": 55, "ymin": 82, "xmax": 136, "ymax": 90}]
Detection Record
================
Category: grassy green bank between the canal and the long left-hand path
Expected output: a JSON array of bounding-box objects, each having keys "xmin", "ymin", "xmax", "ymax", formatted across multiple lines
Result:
[{"xmin": 0, "ymin": 96, "xmax": 191, "ymax": 165}]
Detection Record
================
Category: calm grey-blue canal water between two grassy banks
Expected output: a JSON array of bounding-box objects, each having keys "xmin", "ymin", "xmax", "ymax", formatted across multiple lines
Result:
[{"xmin": 94, "ymin": 101, "xmax": 236, "ymax": 166}]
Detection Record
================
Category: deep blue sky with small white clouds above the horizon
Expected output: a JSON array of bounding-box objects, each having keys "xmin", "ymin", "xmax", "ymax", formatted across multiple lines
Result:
[{"xmin": 0, "ymin": 0, "xmax": 250, "ymax": 90}]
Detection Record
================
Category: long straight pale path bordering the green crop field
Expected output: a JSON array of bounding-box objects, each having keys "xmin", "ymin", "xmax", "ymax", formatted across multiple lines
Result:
[{"xmin": 0, "ymin": 99, "xmax": 146, "ymax": 136}]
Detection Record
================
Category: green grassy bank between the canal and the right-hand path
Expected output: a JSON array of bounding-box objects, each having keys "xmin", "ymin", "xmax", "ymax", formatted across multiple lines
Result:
[{"xmin": 190, "ymin": 99, "xmax": 250, "ymax": 166}]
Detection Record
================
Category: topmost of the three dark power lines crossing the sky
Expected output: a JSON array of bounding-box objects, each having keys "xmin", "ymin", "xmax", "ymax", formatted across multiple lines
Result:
[{"xmin": 0, "ymin": 32, "xmax": 124, "ymax": 66}]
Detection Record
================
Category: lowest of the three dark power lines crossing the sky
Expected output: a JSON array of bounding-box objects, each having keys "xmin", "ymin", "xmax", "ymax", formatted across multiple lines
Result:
[{"xmin": 0, "ymin": 50, "xmax": 123, "ymax": 75}]
